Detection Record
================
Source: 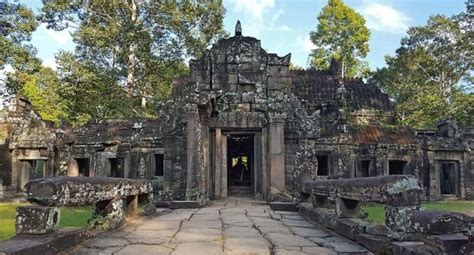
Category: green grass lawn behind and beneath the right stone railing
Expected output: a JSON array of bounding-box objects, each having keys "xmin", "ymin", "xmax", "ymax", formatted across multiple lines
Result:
[{"xmin": 363, "ymin": 200, "xmax": 474, "ymax": 224}]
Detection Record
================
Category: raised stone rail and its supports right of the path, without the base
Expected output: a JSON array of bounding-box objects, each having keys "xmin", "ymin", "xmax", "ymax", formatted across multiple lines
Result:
[{"xmin": 301, "ymin": 175, "xmax": 423, "ymax": 233}]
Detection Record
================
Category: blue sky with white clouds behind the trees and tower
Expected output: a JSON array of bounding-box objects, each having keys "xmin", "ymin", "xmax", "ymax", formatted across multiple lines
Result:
[{"xmin": 22, "ymin": 0, "xmax": 465, "ymax": 68}]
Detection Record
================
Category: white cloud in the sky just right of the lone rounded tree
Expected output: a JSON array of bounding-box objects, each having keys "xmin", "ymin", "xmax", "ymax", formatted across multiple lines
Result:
[{"xmin": 359, "ymin": 0, "xmax": 410, "ymax": 33}]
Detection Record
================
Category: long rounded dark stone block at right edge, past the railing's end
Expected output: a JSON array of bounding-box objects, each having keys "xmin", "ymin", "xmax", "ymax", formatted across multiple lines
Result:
[{"xmin": 411, "ymin": 211, "xmax": 472, "ymax": 235}]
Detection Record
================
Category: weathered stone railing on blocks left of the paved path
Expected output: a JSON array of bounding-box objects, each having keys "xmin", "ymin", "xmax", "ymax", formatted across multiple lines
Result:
[{"xmin": 16, "ymin": 176, "xmax": 153, "ymax": 234}]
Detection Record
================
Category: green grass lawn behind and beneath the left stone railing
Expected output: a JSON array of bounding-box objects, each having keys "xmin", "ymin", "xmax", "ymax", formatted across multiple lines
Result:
[{"xmin": 0, "ymin": 203, "xmax": 92, "ymax": 241}]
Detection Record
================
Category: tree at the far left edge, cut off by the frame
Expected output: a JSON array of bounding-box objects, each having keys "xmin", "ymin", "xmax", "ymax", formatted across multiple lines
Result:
[{"xmin": 0, "ymin": 1, "xmax": 41, "ymax": 99}]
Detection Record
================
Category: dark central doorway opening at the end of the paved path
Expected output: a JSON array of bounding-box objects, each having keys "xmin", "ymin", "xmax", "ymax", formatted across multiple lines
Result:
[{"xmin": 227, "ymin": 134, "xmax": 254, "ymax": 190}]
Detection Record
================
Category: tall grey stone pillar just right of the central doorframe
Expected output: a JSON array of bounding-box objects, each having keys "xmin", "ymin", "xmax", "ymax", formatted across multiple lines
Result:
[{"xmin": 269, "ymin": 116, "xmax": 285, "ymax": 194}]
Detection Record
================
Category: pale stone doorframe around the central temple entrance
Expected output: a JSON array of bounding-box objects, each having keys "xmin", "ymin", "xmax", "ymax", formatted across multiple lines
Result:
[{"xmin": 210, "ymin": 128, "xmax": 262, "ymax": 199}]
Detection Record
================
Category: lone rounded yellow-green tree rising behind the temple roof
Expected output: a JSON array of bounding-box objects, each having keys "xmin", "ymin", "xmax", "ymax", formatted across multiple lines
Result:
[{"xmin": 310, "ymin": 0, "xmax": 370, "ymax": 77}]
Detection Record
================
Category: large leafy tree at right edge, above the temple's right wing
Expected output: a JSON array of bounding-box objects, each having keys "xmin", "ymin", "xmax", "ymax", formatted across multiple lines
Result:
[{"xmin": 372, "ymin": 8, "xmax": 474, "ymax": 128}]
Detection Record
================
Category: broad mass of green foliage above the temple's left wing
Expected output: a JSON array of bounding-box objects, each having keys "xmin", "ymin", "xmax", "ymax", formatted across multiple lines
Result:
[{"xmin": 40, "ymin": 0, "xmax": 224, "ymax": 117}]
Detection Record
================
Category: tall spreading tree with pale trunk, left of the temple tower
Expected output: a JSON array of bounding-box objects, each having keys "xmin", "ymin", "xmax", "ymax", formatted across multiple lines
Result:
[{"xmin": 40, "ymin": 0, "xmax": 224, "ymax": 112}]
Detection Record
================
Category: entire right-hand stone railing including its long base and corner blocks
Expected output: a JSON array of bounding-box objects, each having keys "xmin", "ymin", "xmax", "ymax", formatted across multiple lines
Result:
[{"xmin": 299, "ymin": 174, "xmax": 473, "ymax": 254}]
